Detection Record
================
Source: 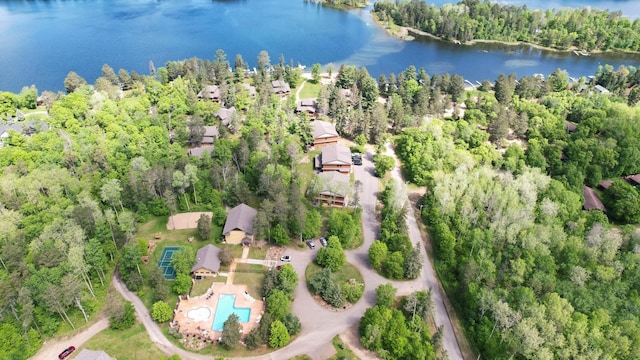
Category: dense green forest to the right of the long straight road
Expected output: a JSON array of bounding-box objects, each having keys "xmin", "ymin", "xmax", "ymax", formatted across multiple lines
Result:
[{"xmin": 382, "ymin": 63, "xmax": 640, "ymax": 359}]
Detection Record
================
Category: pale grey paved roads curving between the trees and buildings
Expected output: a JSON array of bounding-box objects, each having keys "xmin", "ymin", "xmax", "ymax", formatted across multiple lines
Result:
[{"xmin": 33, "ymin": 146, "xmax": 462, "ymax": 360}]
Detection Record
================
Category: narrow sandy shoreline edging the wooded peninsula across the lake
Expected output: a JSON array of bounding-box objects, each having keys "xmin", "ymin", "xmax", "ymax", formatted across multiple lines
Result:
[{"xmin": 371, "ymin": 13, "xmax": 640, "ymax": 56}]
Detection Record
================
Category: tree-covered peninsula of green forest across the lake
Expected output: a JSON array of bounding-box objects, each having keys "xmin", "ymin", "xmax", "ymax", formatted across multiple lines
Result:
[{"xmin": 373, "ymin": 0, "xmax": 640, "ymax": 51}]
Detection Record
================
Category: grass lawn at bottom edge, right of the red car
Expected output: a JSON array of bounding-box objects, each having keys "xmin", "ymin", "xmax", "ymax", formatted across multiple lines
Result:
[{"xmin": 76, "ymin": 322, "xmax": 167, "ymax": 360}]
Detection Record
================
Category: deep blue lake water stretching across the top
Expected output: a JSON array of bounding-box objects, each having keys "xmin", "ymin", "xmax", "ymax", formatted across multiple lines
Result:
[{"xmin": 0, "ymin": 0, "xmax": 640, "ymax": 92}]
